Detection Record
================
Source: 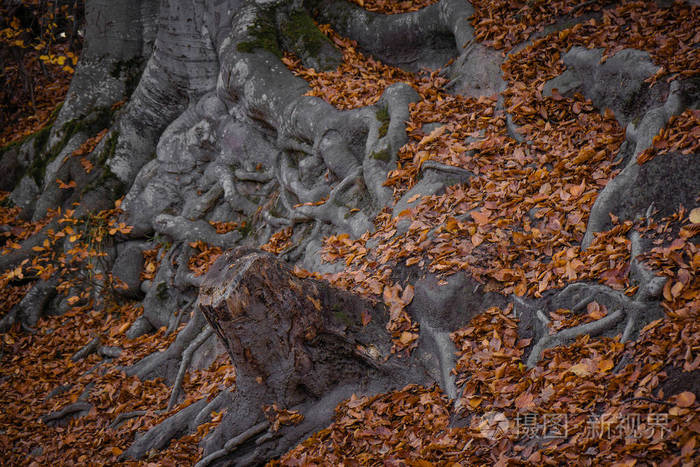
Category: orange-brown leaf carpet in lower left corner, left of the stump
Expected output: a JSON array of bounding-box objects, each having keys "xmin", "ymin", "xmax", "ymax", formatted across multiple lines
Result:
[{"xmin": 0, "ymin": 296, "xmax": 235, "ymax": 465}]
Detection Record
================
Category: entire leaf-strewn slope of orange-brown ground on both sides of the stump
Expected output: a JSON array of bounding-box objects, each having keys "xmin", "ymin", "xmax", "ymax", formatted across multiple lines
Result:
[{"xmin": 0, "ymin": 1, "xmax": 700, "ymax": 465}]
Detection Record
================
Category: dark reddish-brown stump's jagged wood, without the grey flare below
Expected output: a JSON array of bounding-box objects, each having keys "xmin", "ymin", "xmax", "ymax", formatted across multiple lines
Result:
[{"xmin": 199, "ymin": 248, "xmax": 421, "ymax": 407}]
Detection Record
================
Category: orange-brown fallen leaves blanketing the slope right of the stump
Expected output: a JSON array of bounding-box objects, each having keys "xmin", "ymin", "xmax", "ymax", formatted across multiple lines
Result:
[{"xmin": 270, "ymin": 2, "xmax": 700, "ymax": 465}]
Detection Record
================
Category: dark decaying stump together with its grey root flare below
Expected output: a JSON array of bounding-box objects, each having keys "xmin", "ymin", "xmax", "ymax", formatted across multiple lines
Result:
[{"xmin": 198, "ymin": 248, "xmax": 434, "ymax": 462}]
